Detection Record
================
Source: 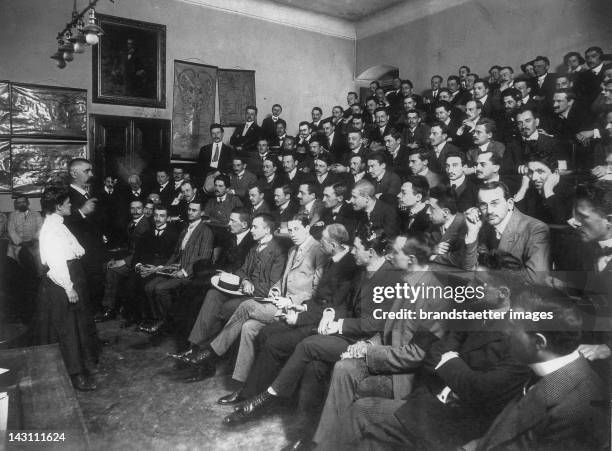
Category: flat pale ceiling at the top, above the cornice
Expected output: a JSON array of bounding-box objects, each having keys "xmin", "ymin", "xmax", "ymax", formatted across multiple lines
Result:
[{"xmin": 272, "ymin": 0, "xmax": 405, "ymax": 22}]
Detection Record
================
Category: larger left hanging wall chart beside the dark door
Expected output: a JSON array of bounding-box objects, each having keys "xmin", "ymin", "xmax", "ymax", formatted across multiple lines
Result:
[{"xmin": 171, "ymin": 60, "xmax": 217, "ymax": 161}]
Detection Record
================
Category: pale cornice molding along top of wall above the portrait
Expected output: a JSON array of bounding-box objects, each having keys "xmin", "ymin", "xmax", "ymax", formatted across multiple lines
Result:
[{"xmin": 178, "ymin": 0, "xmax": 356, "ymax": 40}]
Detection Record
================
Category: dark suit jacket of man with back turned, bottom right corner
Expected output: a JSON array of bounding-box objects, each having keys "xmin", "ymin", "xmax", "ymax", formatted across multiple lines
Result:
[{"xmin": 476, "ymin": 356, "xmax": 610, "ymax": 451}]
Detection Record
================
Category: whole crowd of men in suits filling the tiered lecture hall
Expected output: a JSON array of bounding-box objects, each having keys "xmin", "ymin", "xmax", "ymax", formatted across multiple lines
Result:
[{"xmin": 2, "ymin": 47, "xmax": 612, "ymax": 450}]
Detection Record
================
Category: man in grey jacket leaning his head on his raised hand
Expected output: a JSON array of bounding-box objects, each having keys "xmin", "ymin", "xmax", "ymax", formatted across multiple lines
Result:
[{"xmin": 463, "ymin": 182, "xmax": 550, "ymax": 283}]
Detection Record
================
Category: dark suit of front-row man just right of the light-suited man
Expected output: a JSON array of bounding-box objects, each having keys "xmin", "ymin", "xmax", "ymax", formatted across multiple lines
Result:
[{"xmin": 241, "ymin": 253, "xmax": 357, "ymax": 397}]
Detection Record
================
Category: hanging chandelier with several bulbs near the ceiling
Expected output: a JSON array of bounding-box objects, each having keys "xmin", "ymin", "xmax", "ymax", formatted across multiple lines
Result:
[{"xmin": 51, "ymin": 0, "xmax": 115, "ymax": 69}]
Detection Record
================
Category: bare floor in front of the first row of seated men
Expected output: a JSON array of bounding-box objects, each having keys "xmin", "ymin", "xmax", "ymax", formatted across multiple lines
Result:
[{"xmin": 77, "ymin": 321, "xmax": 292, "ymax": 451}]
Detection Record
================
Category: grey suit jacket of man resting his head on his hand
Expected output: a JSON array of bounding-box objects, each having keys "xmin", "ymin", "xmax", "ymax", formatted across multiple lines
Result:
[{"xmin": 463, "ymin": 208, "xmax": 550, "ymax": 283}]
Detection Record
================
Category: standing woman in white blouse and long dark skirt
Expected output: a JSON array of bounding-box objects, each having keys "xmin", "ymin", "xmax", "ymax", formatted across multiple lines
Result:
[{"xmin": 35, "ymin": 186, "xmax": 99, "ymax": 390}]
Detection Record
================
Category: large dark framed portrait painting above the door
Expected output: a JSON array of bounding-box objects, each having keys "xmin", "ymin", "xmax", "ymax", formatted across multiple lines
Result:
[{"xmin": 92, "ymin": 14, "xmax": 166, "ymax": 108}]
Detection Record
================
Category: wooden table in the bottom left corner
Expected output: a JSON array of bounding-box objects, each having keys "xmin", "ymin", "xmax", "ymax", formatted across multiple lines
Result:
[{"xmin": 0, "ymin": 344, "xmax": 89, "ymax": 450}]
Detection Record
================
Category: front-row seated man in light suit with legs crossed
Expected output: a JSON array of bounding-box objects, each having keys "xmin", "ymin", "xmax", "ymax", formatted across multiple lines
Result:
[{"xmin": 182, "ymin": 215, "xmax": 328, "ymax": 381}]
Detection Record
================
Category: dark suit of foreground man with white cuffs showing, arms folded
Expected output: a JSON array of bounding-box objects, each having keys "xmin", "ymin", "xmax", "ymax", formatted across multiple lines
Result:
[{"xmin": 384, "ymin": 321, "xmax": 531, "ymax": 449}]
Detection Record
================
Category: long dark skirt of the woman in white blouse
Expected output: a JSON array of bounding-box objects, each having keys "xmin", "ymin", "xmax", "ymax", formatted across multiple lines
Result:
[{"xmin": 33, "ymin": 260, "xmax": 100, "ymax": 375}]
